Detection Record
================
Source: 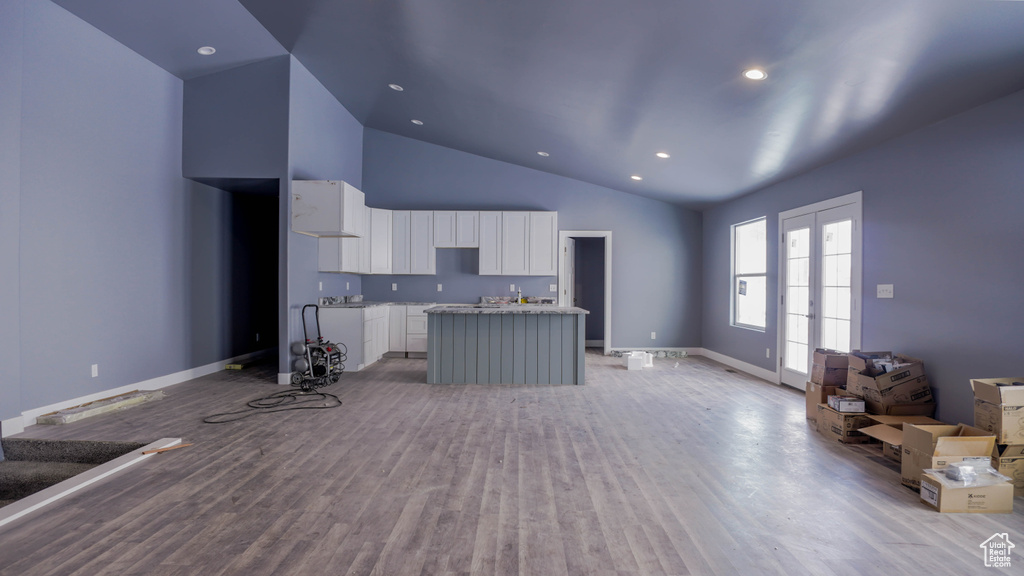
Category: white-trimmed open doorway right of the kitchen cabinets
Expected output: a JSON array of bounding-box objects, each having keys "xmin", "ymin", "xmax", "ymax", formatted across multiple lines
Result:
[{"xmin": 558, "ymin": 230, "xmax": 611, "ymax": 356}]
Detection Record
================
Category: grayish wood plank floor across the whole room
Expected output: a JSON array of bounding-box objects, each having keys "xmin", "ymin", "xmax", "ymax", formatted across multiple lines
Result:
[{"xmin": 0, "ymin": 355, "xmax": 1024, "ymax": 576}]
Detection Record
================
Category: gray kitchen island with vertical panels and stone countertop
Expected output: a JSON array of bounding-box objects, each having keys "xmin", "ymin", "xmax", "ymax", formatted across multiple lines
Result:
[{"xmin": 426, "ymin": 304, "xmax": 589, "ymax": 384}]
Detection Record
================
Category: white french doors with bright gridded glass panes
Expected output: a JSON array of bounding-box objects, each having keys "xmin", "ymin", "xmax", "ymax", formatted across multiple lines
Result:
[{"xmin": 777, "ymin": 193, "xmax": 861, "ymax": 389}]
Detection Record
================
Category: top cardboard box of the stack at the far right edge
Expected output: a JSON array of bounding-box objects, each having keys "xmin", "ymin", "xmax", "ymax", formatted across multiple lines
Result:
[{"xmin": 971, "ymin": 377, "xmax": 1024, "ymax": 444}]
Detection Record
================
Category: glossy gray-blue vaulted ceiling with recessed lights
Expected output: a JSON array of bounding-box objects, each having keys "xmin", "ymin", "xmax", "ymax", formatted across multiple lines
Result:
[{"xmin": 54, "ymin": 0, "xmax": 1024, "ymax": 208}]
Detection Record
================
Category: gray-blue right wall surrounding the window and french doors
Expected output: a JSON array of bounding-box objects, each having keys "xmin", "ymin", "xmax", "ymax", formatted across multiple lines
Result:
[{"xmin": 702, "ymin": 88, "xmax": 1024, "ymax": 423}]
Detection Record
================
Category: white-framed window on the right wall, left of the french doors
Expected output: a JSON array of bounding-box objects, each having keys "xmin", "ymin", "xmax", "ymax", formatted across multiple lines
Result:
[{"xmin": 732, "ymin": 216, "xmax": 768, "ymax": 330}]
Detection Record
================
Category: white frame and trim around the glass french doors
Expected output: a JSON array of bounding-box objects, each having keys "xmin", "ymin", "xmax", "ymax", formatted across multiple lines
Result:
[{"xmin": 775, "ymin": 191, "xmax": 864, "ymax": 385}]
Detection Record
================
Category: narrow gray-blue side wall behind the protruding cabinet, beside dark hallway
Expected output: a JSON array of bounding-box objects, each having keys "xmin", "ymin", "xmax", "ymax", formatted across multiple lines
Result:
[{"xmin": 281, "ymin": 58, "xmax": 373, "ymax": 364}]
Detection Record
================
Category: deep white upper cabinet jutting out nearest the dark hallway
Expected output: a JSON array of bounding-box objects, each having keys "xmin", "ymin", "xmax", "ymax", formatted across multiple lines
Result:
[{"xmin": 292, "ymin": 180, "xmax": 366, "ymax": 238}]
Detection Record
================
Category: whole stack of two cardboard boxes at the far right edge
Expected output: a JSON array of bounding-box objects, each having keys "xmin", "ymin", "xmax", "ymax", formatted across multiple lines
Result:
[{"xmin": 971, "ymin": 377, "xmax": 1024, "ymax": 496}]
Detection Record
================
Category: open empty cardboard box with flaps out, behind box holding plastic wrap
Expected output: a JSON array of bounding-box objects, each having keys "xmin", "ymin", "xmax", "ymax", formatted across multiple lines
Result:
[{"xmin": 900, "ymin": 424, "xmax": 995, "ymax": 490}]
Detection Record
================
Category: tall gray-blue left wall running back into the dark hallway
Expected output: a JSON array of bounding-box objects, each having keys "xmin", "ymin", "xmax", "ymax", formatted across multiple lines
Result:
[{"xmin": 0, "ymin": 0, "xmax": 276, "ymax": 418}]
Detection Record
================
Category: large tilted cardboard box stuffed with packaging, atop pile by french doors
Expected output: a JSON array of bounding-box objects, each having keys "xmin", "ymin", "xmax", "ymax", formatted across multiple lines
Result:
[{"xmin": 846, "ymin": 351, "xmax": 935, "ymax": 416}]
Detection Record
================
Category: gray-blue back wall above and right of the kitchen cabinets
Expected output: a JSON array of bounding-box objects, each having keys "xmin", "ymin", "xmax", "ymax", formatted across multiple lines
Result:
[{"xmin": 362, "ymin": 129, "xmax": 701, "ymax": 347}]
